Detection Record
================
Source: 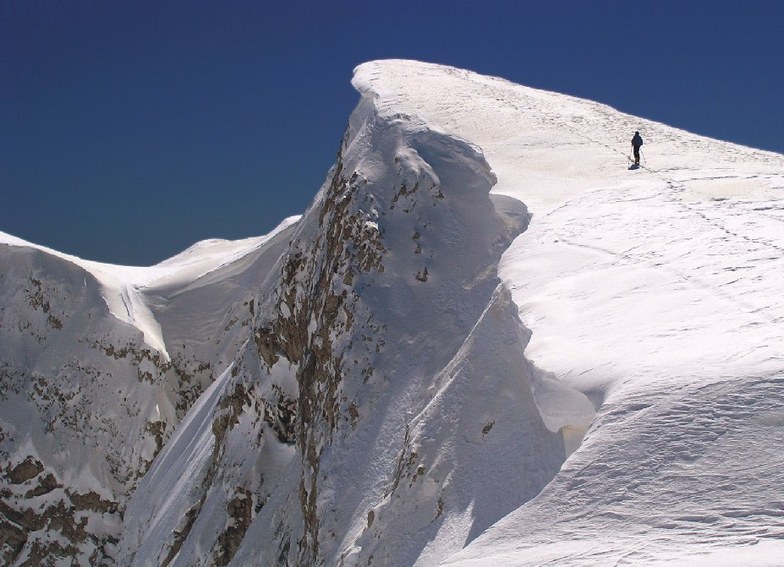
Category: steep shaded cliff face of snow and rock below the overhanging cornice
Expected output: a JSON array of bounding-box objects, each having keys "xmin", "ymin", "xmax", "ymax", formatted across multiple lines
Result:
[{"xmin": 119, "ymin": 65, "xmax": 564, "ymax": 565}]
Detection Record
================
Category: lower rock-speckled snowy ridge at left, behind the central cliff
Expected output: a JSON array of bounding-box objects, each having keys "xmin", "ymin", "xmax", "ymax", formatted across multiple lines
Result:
[{"xmin": 0, "ymin": 219, "xmax": 294, "ymax": 565}]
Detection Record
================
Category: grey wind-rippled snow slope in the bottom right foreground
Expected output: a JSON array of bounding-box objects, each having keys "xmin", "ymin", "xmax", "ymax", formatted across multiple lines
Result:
[{"xmin": 444, "ymin": 374, "xmax": 784, "ymax": 566}]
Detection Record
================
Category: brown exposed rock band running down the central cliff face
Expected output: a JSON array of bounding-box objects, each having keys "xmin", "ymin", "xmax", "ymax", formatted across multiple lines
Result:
[{"xmin": 255, "ymin": 148, "xmax": 392, "ymax": 564}]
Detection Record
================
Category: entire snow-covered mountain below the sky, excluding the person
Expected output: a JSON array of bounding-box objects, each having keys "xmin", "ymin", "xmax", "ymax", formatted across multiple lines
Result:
[{"xmin": 0, "ymin": 61, "xmax": 784, "ymax": 566}]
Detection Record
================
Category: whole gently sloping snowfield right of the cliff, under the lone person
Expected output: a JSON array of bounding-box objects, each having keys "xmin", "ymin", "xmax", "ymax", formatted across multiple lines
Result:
[{"xmin": 355, "ymin": 61, "xmax": 784, "ymax": 565}]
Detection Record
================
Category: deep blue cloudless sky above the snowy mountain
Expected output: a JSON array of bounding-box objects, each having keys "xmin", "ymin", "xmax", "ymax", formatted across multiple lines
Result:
[{"xmin": 0, "ymin": 0, "xmax": 784, "ymax": 265}]
